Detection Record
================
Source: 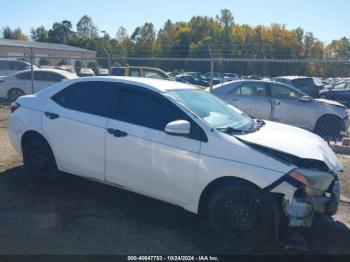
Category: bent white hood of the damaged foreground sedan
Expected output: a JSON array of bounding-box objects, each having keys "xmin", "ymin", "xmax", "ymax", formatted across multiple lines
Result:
[{"xmin": 236, "ymin": 121, "xmax": 343, "ymax": 173}]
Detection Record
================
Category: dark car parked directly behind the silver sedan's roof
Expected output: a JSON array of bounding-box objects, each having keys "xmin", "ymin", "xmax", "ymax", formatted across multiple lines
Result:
[{"xmin": 274, "ymin": 76, "xmax": 323, "ymax": 98}]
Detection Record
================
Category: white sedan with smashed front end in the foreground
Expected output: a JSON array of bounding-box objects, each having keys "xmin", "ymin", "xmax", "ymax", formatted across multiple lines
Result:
[{"xmin": 9, "ymin": 77, "xmax": 342, "ymax": 250}]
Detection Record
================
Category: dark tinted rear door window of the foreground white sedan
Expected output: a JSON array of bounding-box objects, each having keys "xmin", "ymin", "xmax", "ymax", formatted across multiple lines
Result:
[{"xmin": 52, "ymin": 81, "xmax": 115, "ymax": 117}]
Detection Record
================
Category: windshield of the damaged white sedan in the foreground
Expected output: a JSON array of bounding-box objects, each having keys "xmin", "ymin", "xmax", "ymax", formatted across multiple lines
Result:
[{"xmin": 170, "ymin": 89, "xmax": 254, "ymax": 132}]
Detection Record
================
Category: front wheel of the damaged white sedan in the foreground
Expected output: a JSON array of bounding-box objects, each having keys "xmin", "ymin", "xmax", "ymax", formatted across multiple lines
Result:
[{"xmin": 207, "ymin": 183, "xmax": 278, "ymax": 253}]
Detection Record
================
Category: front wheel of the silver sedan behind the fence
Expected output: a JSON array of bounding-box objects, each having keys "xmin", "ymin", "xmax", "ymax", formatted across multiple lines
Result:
[{"xmin": 315, "ymin": 115, "xmax": 342, "ymax": 138}]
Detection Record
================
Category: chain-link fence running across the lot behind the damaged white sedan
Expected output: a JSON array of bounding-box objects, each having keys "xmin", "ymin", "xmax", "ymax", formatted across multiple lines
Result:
[{"xmin": 0, "ymin": 53, "xmax": 350, "ymax": 141}]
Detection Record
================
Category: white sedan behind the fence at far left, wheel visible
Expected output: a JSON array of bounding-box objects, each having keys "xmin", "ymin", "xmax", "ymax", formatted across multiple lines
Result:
[{"xmin": 0, "ymin": 68, "xmax": 77, "ymax": 101}]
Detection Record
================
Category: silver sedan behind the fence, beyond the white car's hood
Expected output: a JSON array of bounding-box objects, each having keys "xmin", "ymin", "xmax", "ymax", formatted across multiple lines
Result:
[{"xmin": 213, "ymin": 80, "xmax": 349, "ymax": 139}]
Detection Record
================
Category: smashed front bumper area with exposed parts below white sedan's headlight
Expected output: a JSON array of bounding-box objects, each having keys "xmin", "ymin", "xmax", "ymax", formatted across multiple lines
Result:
[{"xmin": 271, "ymin": 173, "xmax": 340, "ymax": 227}]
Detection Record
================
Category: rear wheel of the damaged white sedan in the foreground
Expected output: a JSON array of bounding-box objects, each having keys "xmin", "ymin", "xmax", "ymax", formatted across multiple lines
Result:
[{"xmin": 23, "ymin": 136, "xmax": 59, "ymax": 181}]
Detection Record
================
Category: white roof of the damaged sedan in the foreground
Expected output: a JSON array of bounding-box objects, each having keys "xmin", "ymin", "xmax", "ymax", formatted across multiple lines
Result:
[{"xmin": 64, "ymin": 76, "xmax": 198, "ymax": 92}]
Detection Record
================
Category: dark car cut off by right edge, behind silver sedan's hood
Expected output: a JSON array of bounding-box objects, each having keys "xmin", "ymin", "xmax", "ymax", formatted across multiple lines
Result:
[{"xmin": 320, "ymin": 81, "xmax": 350, "ymax": 107}]
